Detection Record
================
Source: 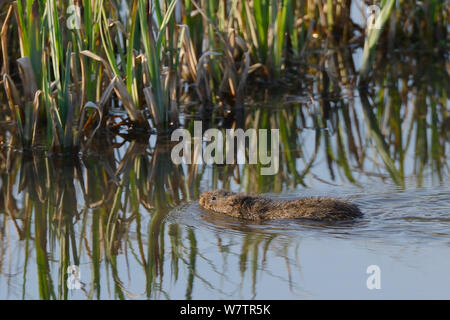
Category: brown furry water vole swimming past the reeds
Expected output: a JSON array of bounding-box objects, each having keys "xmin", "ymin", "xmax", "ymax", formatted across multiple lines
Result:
[{"xmin": 199, "ymin": 190, "xmax": 362, "ymax": 221}]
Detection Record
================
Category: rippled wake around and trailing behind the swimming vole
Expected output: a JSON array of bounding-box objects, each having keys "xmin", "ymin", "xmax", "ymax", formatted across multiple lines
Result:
[{"xmin": 167, "ymin": 182, "xmax": 450, "ymax": 244}]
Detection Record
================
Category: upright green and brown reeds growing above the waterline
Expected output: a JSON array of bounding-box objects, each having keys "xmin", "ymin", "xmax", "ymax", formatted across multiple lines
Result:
[{"xmin": 0, "ymin": 0, "xmax": 449, "ymax": 152}]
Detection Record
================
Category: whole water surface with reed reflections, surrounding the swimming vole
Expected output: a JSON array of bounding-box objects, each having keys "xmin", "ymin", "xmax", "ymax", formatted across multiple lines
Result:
[{"xmin": 0, "ymin": 48, "xmax": 450, "ymax": 299}]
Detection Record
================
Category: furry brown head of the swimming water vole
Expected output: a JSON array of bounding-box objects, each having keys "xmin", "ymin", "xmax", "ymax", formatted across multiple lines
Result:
[{"xmin": 199, "ymin": 190, "xmax": 241, "ymax": 215}]
